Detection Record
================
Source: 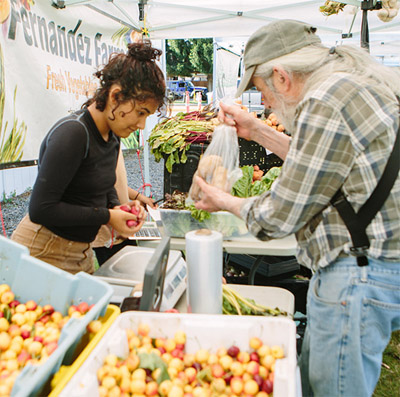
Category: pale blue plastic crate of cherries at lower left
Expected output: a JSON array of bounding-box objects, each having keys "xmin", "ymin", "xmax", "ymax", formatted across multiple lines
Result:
[{"xmin": 0, "ymin": 236, "xmax": 113, "ymax": 397}]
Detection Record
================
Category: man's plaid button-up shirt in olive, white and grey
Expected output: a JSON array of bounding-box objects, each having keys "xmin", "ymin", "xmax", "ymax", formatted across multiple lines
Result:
[{"xmin": 241, "ymin": 73, "xmax": 400, "ymax": 269}]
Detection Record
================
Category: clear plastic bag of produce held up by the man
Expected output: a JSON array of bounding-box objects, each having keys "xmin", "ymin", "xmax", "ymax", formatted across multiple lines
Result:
[{"xmin": 188, "ymin": 120, "xmax": 242, "ymax": 202}]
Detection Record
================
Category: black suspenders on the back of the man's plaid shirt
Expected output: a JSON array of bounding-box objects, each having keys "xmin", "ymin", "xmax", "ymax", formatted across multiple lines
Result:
[{"xmin": 331, "ymin": 106, "xmax": 400, "ymax": 266}]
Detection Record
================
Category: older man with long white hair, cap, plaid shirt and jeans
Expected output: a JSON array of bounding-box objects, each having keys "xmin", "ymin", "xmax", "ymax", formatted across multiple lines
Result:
[{"xmin": 196, "ymin": 20, "xmax": 400, "ymax": 397}]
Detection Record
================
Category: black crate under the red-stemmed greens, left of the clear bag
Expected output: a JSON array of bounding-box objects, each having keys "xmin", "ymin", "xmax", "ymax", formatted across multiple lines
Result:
[{"xmin": 164, "ymin": 143, "xmax": 208, "ymax": 195}]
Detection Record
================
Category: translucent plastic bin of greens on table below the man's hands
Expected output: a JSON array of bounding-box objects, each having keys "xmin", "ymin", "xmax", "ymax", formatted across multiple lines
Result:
[{"xmin": 160, "ymin": 208, "xmax": 249, "ymax": 239}]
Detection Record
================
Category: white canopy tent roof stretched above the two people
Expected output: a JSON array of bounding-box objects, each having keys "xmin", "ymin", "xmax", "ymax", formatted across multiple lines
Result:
[{"xmin": 51, "ymin": 0, "xmax": 400, "ymax": 193}]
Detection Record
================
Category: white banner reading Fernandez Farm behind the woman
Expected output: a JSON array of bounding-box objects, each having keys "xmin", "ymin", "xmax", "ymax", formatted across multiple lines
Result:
[{"xmin": 0, "ymin": 0, "xmax": 133, "ymax": 163}]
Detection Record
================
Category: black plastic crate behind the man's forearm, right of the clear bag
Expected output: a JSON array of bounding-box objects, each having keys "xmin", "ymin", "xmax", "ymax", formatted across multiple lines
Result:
[{"xmin": 239, "ymin": 138, "xmax": 283, "ymax": 172}]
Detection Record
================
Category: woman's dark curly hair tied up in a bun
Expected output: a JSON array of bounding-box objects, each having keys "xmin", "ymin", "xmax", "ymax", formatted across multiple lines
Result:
[{"xmin": 83, "ymin": 41, "xmax": 171, "ymax": 115}]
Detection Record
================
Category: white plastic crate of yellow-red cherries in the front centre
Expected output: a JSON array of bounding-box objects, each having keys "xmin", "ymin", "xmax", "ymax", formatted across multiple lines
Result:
[{"xmin": 59, "ymin": 311, "xmax": 298, "ymax": 397}]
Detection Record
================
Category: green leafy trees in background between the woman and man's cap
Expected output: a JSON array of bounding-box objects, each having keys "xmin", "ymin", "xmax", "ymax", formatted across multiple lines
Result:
[{"xmin": 166, "ymin": 38, "xmax": 214, "ymax": 85}]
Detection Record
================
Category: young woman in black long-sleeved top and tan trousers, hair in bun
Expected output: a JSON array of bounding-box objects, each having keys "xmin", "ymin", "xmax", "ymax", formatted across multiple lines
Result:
[{"xmin": 11, "ymin": 41, "xmax": 168, "ymax": 273}]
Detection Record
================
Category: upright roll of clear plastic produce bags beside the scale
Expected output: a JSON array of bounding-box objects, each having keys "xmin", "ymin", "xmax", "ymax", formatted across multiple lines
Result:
[{"xmin": 185, "ymin": 229, "xmax": 223, "ymax": 314}]
